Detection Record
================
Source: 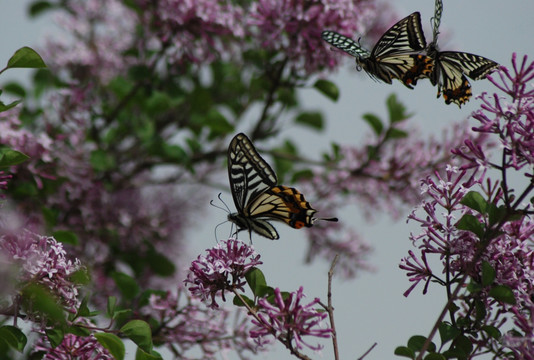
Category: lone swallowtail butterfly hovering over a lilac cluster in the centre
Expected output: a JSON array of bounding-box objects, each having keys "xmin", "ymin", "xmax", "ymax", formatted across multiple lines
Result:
[{"xmin": 228, "ymin": 133, "xmax": 337, "ymax": 240}]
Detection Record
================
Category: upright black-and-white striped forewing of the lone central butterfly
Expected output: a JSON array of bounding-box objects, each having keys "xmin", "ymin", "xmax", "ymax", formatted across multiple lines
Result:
[{"xmin": 228, "ymin": 133, "xmax": 278, "ymax": 214}]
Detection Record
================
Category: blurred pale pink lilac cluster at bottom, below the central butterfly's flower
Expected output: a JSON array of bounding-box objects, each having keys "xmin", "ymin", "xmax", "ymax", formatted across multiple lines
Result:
[{"xmin": 142, "ymin": 288, "xmax": 259, "ymax": 359}]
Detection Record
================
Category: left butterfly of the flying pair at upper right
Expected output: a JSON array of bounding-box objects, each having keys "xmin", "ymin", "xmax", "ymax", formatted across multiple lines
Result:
[{"xmin": 321, "ymin": 12, "xmax": 434, "ymax": 89}]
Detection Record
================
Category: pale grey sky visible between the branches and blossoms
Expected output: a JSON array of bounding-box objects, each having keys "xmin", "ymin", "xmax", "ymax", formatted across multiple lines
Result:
[{"xmin": 0, "ymin": 0, "xmax": 534, "ymax": 360}]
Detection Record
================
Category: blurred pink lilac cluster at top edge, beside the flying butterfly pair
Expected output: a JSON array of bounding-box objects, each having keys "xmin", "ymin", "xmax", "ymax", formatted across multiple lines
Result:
[{"xmin": 247, "ymin": 0, "xmax": 394, "ymax": 75}]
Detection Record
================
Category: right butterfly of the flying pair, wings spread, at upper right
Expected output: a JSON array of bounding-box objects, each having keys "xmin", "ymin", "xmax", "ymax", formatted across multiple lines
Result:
[{"xmin": 426, "ymin": 0, "xmax": 499, "ymax": 107}]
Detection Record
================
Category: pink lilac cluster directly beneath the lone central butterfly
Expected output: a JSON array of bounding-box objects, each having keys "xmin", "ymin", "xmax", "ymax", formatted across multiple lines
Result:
[{"xmin": 184, "ymin": 239, "xmax": 262, "ymax": 309}]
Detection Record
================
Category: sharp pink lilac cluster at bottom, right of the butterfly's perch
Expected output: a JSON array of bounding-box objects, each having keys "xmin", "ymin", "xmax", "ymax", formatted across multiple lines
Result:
[{"xmin": 250, "ymin": 286, "xmax": 332, "ymax": 350}]
